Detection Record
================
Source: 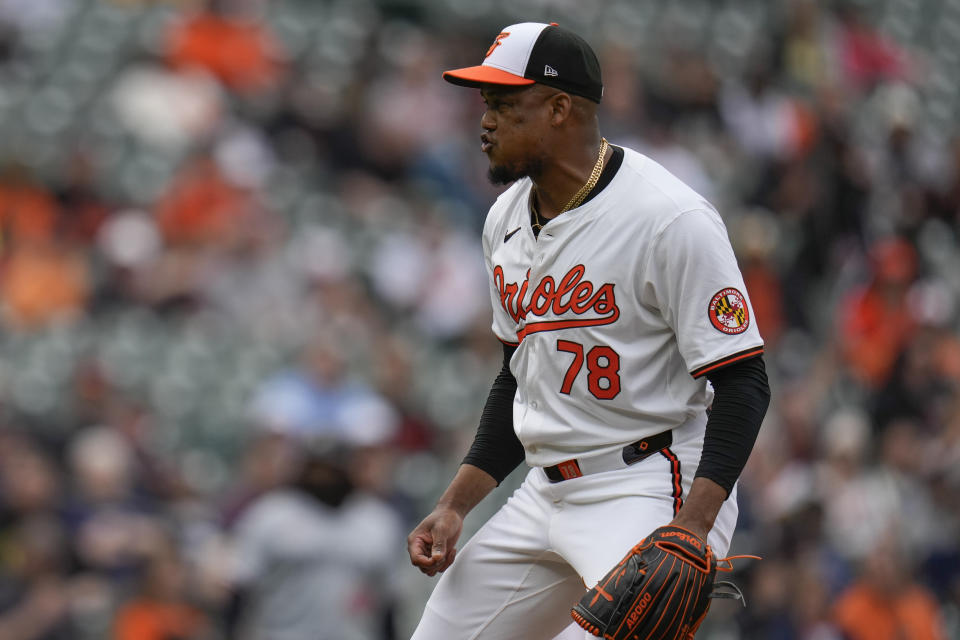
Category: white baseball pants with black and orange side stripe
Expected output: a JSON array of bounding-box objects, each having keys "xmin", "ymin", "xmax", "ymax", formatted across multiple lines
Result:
[{"xmin": 411, "ymin": 421, "xmax": 737, "ymax": 640}]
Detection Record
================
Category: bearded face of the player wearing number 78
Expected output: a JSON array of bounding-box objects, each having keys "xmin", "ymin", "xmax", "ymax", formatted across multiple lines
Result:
[{"xmin": 480, "ymin": 85, "xmax": 557, "ymax": 184}]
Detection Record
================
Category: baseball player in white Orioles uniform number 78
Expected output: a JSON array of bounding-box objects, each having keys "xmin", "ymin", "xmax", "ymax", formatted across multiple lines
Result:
[{"xmin": 408, "ymin": 23, "xmax": 769, "ymax": 640}]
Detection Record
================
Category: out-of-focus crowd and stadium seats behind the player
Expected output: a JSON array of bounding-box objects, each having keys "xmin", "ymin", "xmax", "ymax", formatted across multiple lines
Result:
[{"xmin": 0, "ymin": 0, "xmax": 960, "ymax": 640}]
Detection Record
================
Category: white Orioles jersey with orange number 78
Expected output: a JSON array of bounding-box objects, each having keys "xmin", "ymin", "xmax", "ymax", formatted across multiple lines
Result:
[{"xmin": 483, "ymin": 149, "xmax": 763, "ymax": 467}]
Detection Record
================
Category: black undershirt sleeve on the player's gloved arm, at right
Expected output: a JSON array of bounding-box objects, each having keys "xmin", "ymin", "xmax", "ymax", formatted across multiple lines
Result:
[{"xmin": 696, "ymin": 356, "xmax": 770, "ymax": 495}]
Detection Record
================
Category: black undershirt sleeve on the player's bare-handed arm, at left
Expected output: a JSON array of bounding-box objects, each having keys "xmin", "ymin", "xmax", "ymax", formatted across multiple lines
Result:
[{"xmin": 463, "ymin": 344, "xmax": 526, "ymax": 484}]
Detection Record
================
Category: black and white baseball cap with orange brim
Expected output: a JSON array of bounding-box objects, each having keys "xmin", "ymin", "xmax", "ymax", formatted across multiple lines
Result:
[{"xmin": 443, "ymin": 22, "xmax": 603, "ymax": 102}]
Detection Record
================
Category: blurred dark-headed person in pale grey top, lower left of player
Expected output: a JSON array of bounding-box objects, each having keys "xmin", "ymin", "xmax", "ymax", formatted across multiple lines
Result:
[{"xmin": 230, "ymin": 442, "xmax": 403, "ymax": 640}]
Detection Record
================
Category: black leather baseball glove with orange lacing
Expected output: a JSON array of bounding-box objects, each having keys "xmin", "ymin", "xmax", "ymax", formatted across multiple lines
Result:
[{"xmin": 572, "ymin": 526, "xmax": 717, "ymax": 640}]
